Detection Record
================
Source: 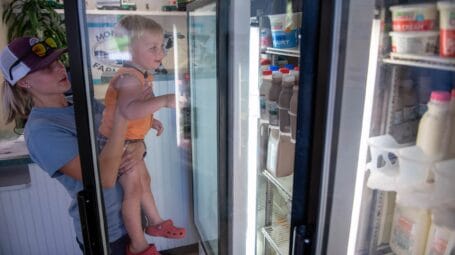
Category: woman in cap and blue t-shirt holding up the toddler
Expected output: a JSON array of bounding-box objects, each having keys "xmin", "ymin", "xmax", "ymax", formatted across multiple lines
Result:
[{"xmin": 0, "ymin": 37, "xmax": 159, "ymax": 254}]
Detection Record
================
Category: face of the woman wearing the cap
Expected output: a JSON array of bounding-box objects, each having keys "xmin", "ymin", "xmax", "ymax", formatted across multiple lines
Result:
[{"xmin": 25, "ymin": 60, "xmax": 71, "ymax": 96}]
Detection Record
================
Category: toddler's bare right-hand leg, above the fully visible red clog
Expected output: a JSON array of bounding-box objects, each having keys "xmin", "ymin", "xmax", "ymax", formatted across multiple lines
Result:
[{"xmin": 141, "ymin": 164, "xmax": 163, "ymax": 225}]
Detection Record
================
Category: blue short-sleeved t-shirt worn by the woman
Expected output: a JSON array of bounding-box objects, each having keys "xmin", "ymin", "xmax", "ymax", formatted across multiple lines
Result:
[{"xmin": 24, "ymin": 106, "xmax": 126, "ymax": 242}]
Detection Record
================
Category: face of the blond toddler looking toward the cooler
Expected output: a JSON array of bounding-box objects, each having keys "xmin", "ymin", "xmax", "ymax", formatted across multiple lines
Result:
[{"xmin": 131, "ymin": 32, "xmax": 165, "ymax": 69}]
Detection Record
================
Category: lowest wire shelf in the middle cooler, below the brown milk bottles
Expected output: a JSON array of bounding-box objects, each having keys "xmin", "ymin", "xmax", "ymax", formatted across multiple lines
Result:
[{"xmin": 261, "ymin": 224, "xmax": 290, "ymax": 255}]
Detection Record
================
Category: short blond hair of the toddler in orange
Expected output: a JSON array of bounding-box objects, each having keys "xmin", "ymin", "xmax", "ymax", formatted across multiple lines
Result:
[{"xmin": 115, "ymin": 15, "xmax": 164, "ymax": 48}]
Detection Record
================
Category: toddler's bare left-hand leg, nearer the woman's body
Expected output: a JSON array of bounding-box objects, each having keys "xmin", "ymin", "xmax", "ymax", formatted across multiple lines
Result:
[{"xmin": 119, "ymin": 166, "xmax": 148, "ymax": 253}]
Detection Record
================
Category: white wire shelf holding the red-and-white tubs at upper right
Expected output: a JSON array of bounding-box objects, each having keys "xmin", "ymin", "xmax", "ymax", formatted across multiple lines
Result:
[{"xmin": 383, "ymin": 52, "xmax": 455, "ymax": 71}]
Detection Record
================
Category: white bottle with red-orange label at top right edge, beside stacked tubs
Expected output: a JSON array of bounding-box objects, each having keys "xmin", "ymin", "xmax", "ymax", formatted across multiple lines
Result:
[{"xmin": 437, "ymin": 1, "xmax": 455, "ymax": 57}]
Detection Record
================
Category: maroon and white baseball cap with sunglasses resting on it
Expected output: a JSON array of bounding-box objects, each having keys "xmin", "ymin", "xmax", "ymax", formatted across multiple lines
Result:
[{"xmin": 0, "ymin": 37, "xmax": 67, "ymax": 85}]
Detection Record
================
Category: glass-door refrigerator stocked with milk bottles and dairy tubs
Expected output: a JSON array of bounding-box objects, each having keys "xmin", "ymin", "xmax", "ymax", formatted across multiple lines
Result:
[{"xmin": 188, "ymin": 0, "xmax": 455, "ymax": 254}]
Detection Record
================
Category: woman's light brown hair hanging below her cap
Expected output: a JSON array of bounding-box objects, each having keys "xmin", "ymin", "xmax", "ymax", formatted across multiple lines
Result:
[{"xmin": 2, "ymin": 80, "xmax": 33, "ymax": 123}]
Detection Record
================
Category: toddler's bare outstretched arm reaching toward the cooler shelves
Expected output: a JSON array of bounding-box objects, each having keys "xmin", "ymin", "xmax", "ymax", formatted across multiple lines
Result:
[{"xmin": 115, "ymin": 75, "xmax": 175, "ymax": 119}]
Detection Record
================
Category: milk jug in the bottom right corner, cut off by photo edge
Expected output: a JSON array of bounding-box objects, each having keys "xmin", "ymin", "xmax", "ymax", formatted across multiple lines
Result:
[{"xmin": 425, "ymin": 219, "xmax": 455, "ymax": 255}]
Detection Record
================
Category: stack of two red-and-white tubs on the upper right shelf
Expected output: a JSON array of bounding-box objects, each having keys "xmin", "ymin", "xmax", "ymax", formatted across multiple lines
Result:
[{"xmin": 390, "ymin": 3, "xmax": 439, "ymax": 55}]
